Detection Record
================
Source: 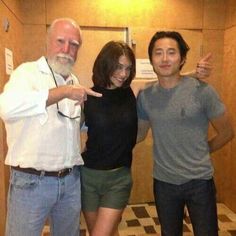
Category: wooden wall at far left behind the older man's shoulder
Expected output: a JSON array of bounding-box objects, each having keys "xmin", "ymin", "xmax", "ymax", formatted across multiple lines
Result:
[{"xmin": 0, "ymin": 0, "xmax": 23, "ymax": 235}]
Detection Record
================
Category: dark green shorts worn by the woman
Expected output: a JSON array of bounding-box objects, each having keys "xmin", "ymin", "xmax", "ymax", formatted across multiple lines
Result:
[{"xmin": 81, "ymin": 167, "xmax": 133, "ymax": 211}]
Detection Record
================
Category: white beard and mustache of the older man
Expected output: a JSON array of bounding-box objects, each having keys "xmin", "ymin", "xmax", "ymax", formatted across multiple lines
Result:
[{"xmin": 48, "ymin": 53, "xmax": 75, "ymax": 76}]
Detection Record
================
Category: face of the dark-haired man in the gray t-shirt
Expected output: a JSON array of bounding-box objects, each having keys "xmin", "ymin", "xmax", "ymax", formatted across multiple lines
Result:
[{"xmin": 152, "ymin": 38, "xmax": 184, "ymax": 77}]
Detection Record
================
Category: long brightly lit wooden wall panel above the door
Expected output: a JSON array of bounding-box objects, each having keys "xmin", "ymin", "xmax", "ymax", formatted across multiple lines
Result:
[{"xmin": 46, "ymin": 0, "xmax": 203, "ymax": 29}]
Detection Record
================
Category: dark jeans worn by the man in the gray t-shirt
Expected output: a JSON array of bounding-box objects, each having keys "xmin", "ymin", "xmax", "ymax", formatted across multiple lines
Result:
[{"xmin": 153, "ymin": 179, "xmax": 218, "ymax": 236}]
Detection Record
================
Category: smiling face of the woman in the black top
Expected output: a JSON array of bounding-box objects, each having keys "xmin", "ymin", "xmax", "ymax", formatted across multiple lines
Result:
[{"xmin": 109, "ymin": 55, "xmax": 132, "ymax": 89}]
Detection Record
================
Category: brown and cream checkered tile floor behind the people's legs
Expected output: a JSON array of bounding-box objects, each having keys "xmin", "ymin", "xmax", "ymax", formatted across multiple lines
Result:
[{"xmin": 43, "ymin": 203, "xmax": 236, "ymax": 236}]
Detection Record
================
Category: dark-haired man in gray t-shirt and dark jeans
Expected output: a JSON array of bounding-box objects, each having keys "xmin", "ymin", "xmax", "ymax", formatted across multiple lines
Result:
[{"xmin": 137, "ymin": 31, "xmax": 234, "ymax": 236}]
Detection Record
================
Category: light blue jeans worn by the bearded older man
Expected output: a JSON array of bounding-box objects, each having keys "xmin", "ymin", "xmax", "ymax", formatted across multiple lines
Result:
[{"xmin": 6, "ymin": 167, "xmax": 81, "ymax": 236}]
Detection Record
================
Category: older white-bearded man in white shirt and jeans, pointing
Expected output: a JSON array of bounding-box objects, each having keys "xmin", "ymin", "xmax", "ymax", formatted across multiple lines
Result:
[{"xmin": 0, "ymin": 18, "xmax": 101, "ymax": 236}]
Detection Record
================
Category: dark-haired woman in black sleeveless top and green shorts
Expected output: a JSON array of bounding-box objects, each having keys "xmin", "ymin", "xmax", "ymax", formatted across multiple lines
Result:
[{"xmin": 81, "ymin": 41, "xmax": 209, "ymax": 236}]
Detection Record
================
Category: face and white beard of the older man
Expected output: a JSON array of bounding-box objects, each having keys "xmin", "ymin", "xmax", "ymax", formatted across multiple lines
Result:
[{"xmin": 47, "ymin": 21, "xmax": 81, "ymax": 76}]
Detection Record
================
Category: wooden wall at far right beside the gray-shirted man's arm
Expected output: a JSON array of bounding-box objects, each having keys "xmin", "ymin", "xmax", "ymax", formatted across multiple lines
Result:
[{"xmin": 219, "ymin": 0, "xmax": 236, "ymax": 211}]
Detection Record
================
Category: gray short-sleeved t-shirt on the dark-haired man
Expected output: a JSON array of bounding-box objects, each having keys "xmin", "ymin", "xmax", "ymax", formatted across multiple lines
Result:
[{"xmin": 137, "ymin": 77, "xmax": 225, "ymax": 184}]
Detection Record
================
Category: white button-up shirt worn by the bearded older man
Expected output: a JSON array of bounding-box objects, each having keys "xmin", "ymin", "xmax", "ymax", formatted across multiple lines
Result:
[{"xmin": 0, "ymin": 57, "xmax": 83, "ymax": 171}]
